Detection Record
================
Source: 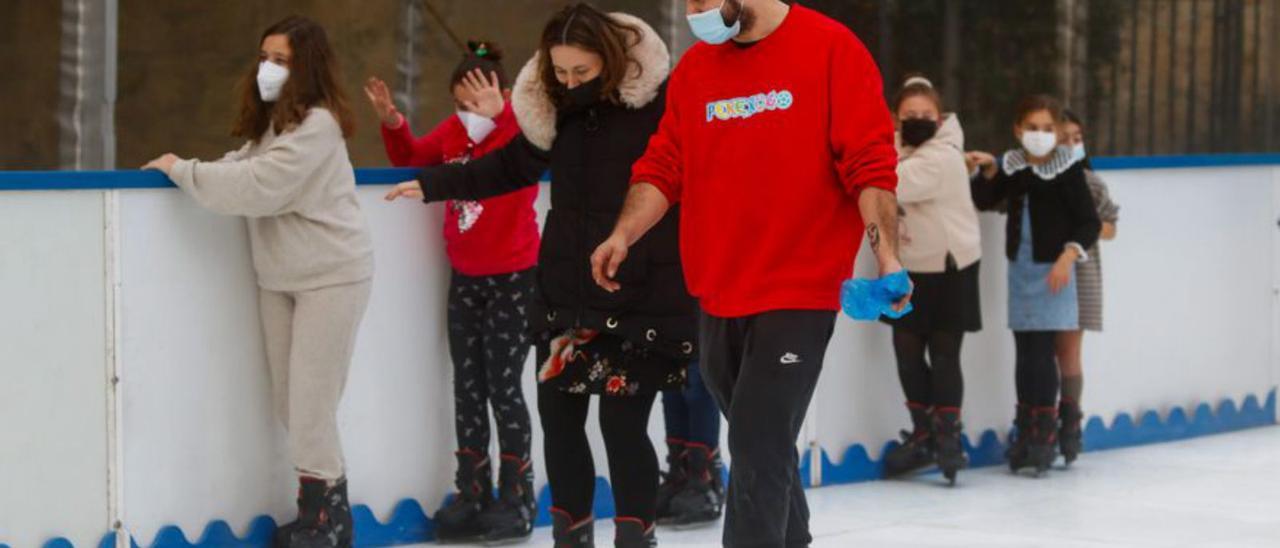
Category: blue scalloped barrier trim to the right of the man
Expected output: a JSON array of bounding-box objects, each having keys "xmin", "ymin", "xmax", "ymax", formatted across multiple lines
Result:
[{"xmin": 824, "ymin": 389, "xmax": 1276, "ymax": 485}]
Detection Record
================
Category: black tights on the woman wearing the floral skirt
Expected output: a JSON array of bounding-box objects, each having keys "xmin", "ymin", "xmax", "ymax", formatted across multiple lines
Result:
[{"xmin": 538, "ymin": 384, "xmax": 658, "ymax": 524}]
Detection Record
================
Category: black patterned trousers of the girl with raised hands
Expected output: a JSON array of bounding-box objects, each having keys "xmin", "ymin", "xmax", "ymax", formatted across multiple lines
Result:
[{"xmin": 448, "ymin": 270, "xmax": 534, "ymax": 461}]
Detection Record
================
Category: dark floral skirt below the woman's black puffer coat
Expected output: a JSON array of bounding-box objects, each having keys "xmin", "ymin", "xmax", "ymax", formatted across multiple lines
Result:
[{"xmin": 535, "ymin": 329, "xmax": 687, "ymax": 396}]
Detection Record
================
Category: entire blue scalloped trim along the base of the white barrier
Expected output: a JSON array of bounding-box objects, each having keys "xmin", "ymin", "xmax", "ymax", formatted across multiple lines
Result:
[{"xmin": 27, "ymin": 389, "xmax": 1276, "ymax": 548}]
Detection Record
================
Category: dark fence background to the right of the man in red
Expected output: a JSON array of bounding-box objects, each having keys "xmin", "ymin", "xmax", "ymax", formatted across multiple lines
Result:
[{"xmin": 804, "ymin": 0, "xmax": 1280, "ymax": 155}]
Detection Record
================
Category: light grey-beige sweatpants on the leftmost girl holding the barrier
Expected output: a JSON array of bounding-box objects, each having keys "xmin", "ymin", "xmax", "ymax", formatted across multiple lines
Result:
[{"xmin": 259, "ymin": 280, "xmax": 372, "ymax": 480}]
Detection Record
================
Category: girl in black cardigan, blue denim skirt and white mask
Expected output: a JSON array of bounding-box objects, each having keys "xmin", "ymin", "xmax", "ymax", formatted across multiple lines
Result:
[{"xmin": 968, "ymin": 96, "xmax": 1101, "ymax": 475}]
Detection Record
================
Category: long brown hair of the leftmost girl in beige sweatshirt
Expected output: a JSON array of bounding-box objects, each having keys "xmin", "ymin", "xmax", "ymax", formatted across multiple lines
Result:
[{"xmin": 232, "ymin": 15, "xmax": 356, "ymax": 141}]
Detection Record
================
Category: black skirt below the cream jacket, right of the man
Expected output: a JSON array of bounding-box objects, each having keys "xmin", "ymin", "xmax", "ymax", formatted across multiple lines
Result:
[{"xmin": 884, "ymin": 260, "xmax": 982, "ymax": 334}]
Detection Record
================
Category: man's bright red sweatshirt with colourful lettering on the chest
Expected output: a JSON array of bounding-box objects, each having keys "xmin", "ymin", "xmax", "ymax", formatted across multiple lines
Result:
[{"xmin": 632, "ymin": 5, "xmax": 897, "ymax": 318}]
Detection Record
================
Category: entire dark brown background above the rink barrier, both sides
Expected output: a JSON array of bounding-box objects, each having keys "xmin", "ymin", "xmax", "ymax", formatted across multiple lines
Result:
[{"xmin": 0, "ymin": 0, "xmax": 1280, "ymax": 169}]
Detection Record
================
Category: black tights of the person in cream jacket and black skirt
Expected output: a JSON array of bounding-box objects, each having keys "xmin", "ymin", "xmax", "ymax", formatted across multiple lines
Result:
[{"xmin": 893, "ymin": 328, "xmax": 964, "ymax": 407}]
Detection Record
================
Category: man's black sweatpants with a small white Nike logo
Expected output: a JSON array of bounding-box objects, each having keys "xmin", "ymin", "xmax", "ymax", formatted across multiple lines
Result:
[{"xmin": 699, "ymin": 310, "xmax": 836, "ymax": 548}]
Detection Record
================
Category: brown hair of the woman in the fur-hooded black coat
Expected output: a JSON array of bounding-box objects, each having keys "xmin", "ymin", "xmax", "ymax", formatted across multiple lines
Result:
[{"xmin": 538, "ymin": 3, "xmax": 644, "ymax": 105}]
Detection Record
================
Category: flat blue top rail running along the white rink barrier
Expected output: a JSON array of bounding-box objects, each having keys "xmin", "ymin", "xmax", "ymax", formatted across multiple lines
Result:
[{"xmin": 0, "ymin": 154, "xmax": 1280, "ymax": 192}]
